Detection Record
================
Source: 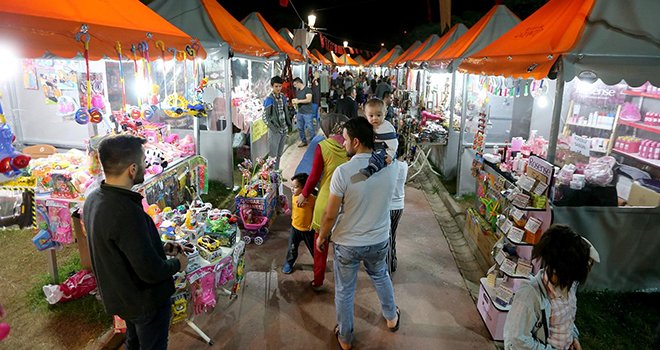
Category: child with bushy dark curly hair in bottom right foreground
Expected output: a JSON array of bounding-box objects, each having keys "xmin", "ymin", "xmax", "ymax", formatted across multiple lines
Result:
[{"xmin": 504, "ymin": 225, "xmax": 600, "ymax": 350}]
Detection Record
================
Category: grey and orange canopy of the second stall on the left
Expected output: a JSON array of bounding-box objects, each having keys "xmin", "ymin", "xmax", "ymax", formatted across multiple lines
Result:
[{"xmin": 148, "ymin": 0, "xmax": 275, "ymax": 57}]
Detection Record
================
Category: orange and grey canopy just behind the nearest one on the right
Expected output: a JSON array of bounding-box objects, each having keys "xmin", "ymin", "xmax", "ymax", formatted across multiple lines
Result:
[{"xmin": 428, "ymin": 5, "xmax": 520, "ymax": 70}]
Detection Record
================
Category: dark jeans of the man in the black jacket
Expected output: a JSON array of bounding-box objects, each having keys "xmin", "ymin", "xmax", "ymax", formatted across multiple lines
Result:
[{"xmin": 125, "ymin": 301, "xmax": 172, "ymax": 350}]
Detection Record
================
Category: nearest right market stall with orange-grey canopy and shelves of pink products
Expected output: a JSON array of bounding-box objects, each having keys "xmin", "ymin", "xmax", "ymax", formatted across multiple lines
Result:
[{"xmin": 454, "ymin": 0, "xmax": 660, "ymax": 339}]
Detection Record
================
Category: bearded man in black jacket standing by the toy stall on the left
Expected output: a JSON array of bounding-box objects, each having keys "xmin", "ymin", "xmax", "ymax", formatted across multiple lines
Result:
[{"xmin": 83, "ymin": 135, "xmax": 188, "ymax": 350}]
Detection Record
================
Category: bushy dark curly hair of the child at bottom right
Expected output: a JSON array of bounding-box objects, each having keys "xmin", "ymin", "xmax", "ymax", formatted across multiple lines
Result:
[{"xmin": 532, "ymin": 225, "xmax": 590, "ymax": 288}]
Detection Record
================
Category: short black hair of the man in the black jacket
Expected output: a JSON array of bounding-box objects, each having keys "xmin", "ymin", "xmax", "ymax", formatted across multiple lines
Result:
[{"xmin": 99, "ymin": 134, "xmax": 147, "ymax": 176}]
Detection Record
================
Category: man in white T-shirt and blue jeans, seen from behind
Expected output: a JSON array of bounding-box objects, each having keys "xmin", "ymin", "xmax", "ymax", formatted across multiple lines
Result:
[{"xmin": 316, "ymin": 118, "xmax": 400, "ymax": 349}]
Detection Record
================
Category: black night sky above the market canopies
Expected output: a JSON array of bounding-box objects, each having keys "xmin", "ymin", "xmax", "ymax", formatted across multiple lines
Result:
[{"xmin": 218, "ymin": 0, "xmax": 545, "ymax": 56}]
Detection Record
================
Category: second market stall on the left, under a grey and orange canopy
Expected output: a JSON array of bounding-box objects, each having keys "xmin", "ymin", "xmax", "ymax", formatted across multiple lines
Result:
[{"xmin": 149, "ymin": 0, "xmax": 275, "ymax": 178}]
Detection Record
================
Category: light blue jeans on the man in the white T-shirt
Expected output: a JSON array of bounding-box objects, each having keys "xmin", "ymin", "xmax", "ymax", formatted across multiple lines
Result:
[{"xmin": 334, "ymin": 239, "xmax": 396, "ymax": 343}]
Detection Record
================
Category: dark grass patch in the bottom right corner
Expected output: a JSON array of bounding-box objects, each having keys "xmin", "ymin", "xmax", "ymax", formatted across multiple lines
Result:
[{"xmin": 575, "ymin": 291, "xmax": 660, "ymax": 349}]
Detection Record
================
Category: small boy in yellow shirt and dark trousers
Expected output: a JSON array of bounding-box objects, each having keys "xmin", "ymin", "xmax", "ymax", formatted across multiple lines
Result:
[{"xmin": 282, "ymin": 173, "xmax": 316, "ymax": 274}]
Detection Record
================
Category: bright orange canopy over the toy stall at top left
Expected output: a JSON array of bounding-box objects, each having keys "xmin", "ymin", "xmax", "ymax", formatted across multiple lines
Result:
[{"xmin": 0, "ymin": 0, "xmax": 206, "ymax": 60}]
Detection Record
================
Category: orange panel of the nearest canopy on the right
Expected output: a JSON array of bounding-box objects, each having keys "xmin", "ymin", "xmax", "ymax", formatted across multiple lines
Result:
[{"xmin": 459, "ymin": 0, "xmax": 595, "ymax": 79}]
